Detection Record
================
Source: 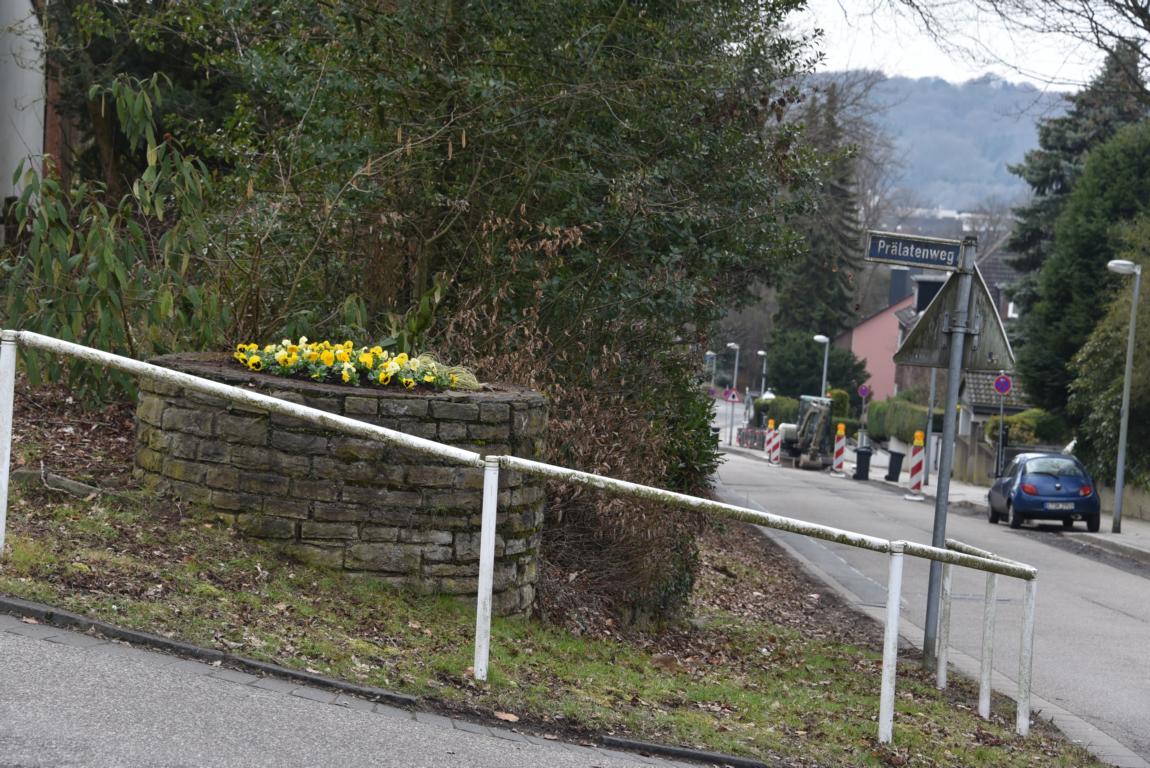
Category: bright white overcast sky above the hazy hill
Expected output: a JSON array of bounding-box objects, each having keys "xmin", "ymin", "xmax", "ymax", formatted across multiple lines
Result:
[{"xmin": 798, "ymin": 0, "xmax": 1101, "ymax": 90}]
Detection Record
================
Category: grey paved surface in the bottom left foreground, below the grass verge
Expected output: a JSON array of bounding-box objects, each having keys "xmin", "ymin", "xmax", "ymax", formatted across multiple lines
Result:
[{"xmin": 0, "ymin": 614, "xmax": 697, "ymax": 768}]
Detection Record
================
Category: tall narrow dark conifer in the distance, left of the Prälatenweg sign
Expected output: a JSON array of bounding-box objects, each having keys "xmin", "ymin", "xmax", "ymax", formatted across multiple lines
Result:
[{"xmin": 779, "ymin": 84, "xmax": 863, "ymax": 336}]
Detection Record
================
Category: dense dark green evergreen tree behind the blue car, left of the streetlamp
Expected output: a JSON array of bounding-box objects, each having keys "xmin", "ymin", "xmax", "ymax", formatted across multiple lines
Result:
[{"xmin": 1018, "ymin": 121, "xmax": 1150, "ymax": 413}]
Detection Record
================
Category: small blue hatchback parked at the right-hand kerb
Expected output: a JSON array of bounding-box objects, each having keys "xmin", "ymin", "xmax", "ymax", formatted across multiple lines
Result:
[{"xmin": 987, "ymin": 453, "xmax": 1101, "ymax": 533}]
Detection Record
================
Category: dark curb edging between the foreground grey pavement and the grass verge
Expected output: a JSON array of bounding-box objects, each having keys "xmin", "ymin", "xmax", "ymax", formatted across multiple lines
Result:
[{"xmin": 0, "ymin": 594, "xmax": 771, "ymax": 768}]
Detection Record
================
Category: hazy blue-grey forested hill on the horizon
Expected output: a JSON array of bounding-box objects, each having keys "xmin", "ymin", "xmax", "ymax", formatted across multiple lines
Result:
[{"xmin": 832, "ymin": 76, "xmax": 1063, "ymax": 209}]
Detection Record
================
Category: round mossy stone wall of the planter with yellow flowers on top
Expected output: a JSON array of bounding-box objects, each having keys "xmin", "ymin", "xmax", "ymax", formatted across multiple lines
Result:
[{"xmin": 136, "ymin": 354, "xmax": 546, "ymax": 614}]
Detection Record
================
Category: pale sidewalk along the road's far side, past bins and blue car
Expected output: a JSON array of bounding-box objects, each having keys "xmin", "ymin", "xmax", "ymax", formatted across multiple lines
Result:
[{"xmin": 720, "ymin": 444, "xmax": 1150, "ymax": 565}]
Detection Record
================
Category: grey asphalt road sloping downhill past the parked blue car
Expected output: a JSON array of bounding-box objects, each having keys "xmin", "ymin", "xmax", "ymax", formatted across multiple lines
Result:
[{"xmin": 719, "ymin": 450, "xmax": 1150, "ymax": 766}]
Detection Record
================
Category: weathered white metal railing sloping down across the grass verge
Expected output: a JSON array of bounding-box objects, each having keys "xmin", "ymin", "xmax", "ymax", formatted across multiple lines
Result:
[{"xmin": 0, "ymin": 330, "xmax": 1037, "ymax": 743}]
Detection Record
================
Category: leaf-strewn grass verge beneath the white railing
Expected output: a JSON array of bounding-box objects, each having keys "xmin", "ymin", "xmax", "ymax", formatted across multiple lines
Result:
[{"xmin": 0, "ymin": 490, "xmax": 1103, "ymax": 767}]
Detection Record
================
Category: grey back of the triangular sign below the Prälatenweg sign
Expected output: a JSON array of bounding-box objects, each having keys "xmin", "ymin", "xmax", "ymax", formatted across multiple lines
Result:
[{"xmin": 895, "ymin": 267, "xmax": 1014, "ymax": 373}]
